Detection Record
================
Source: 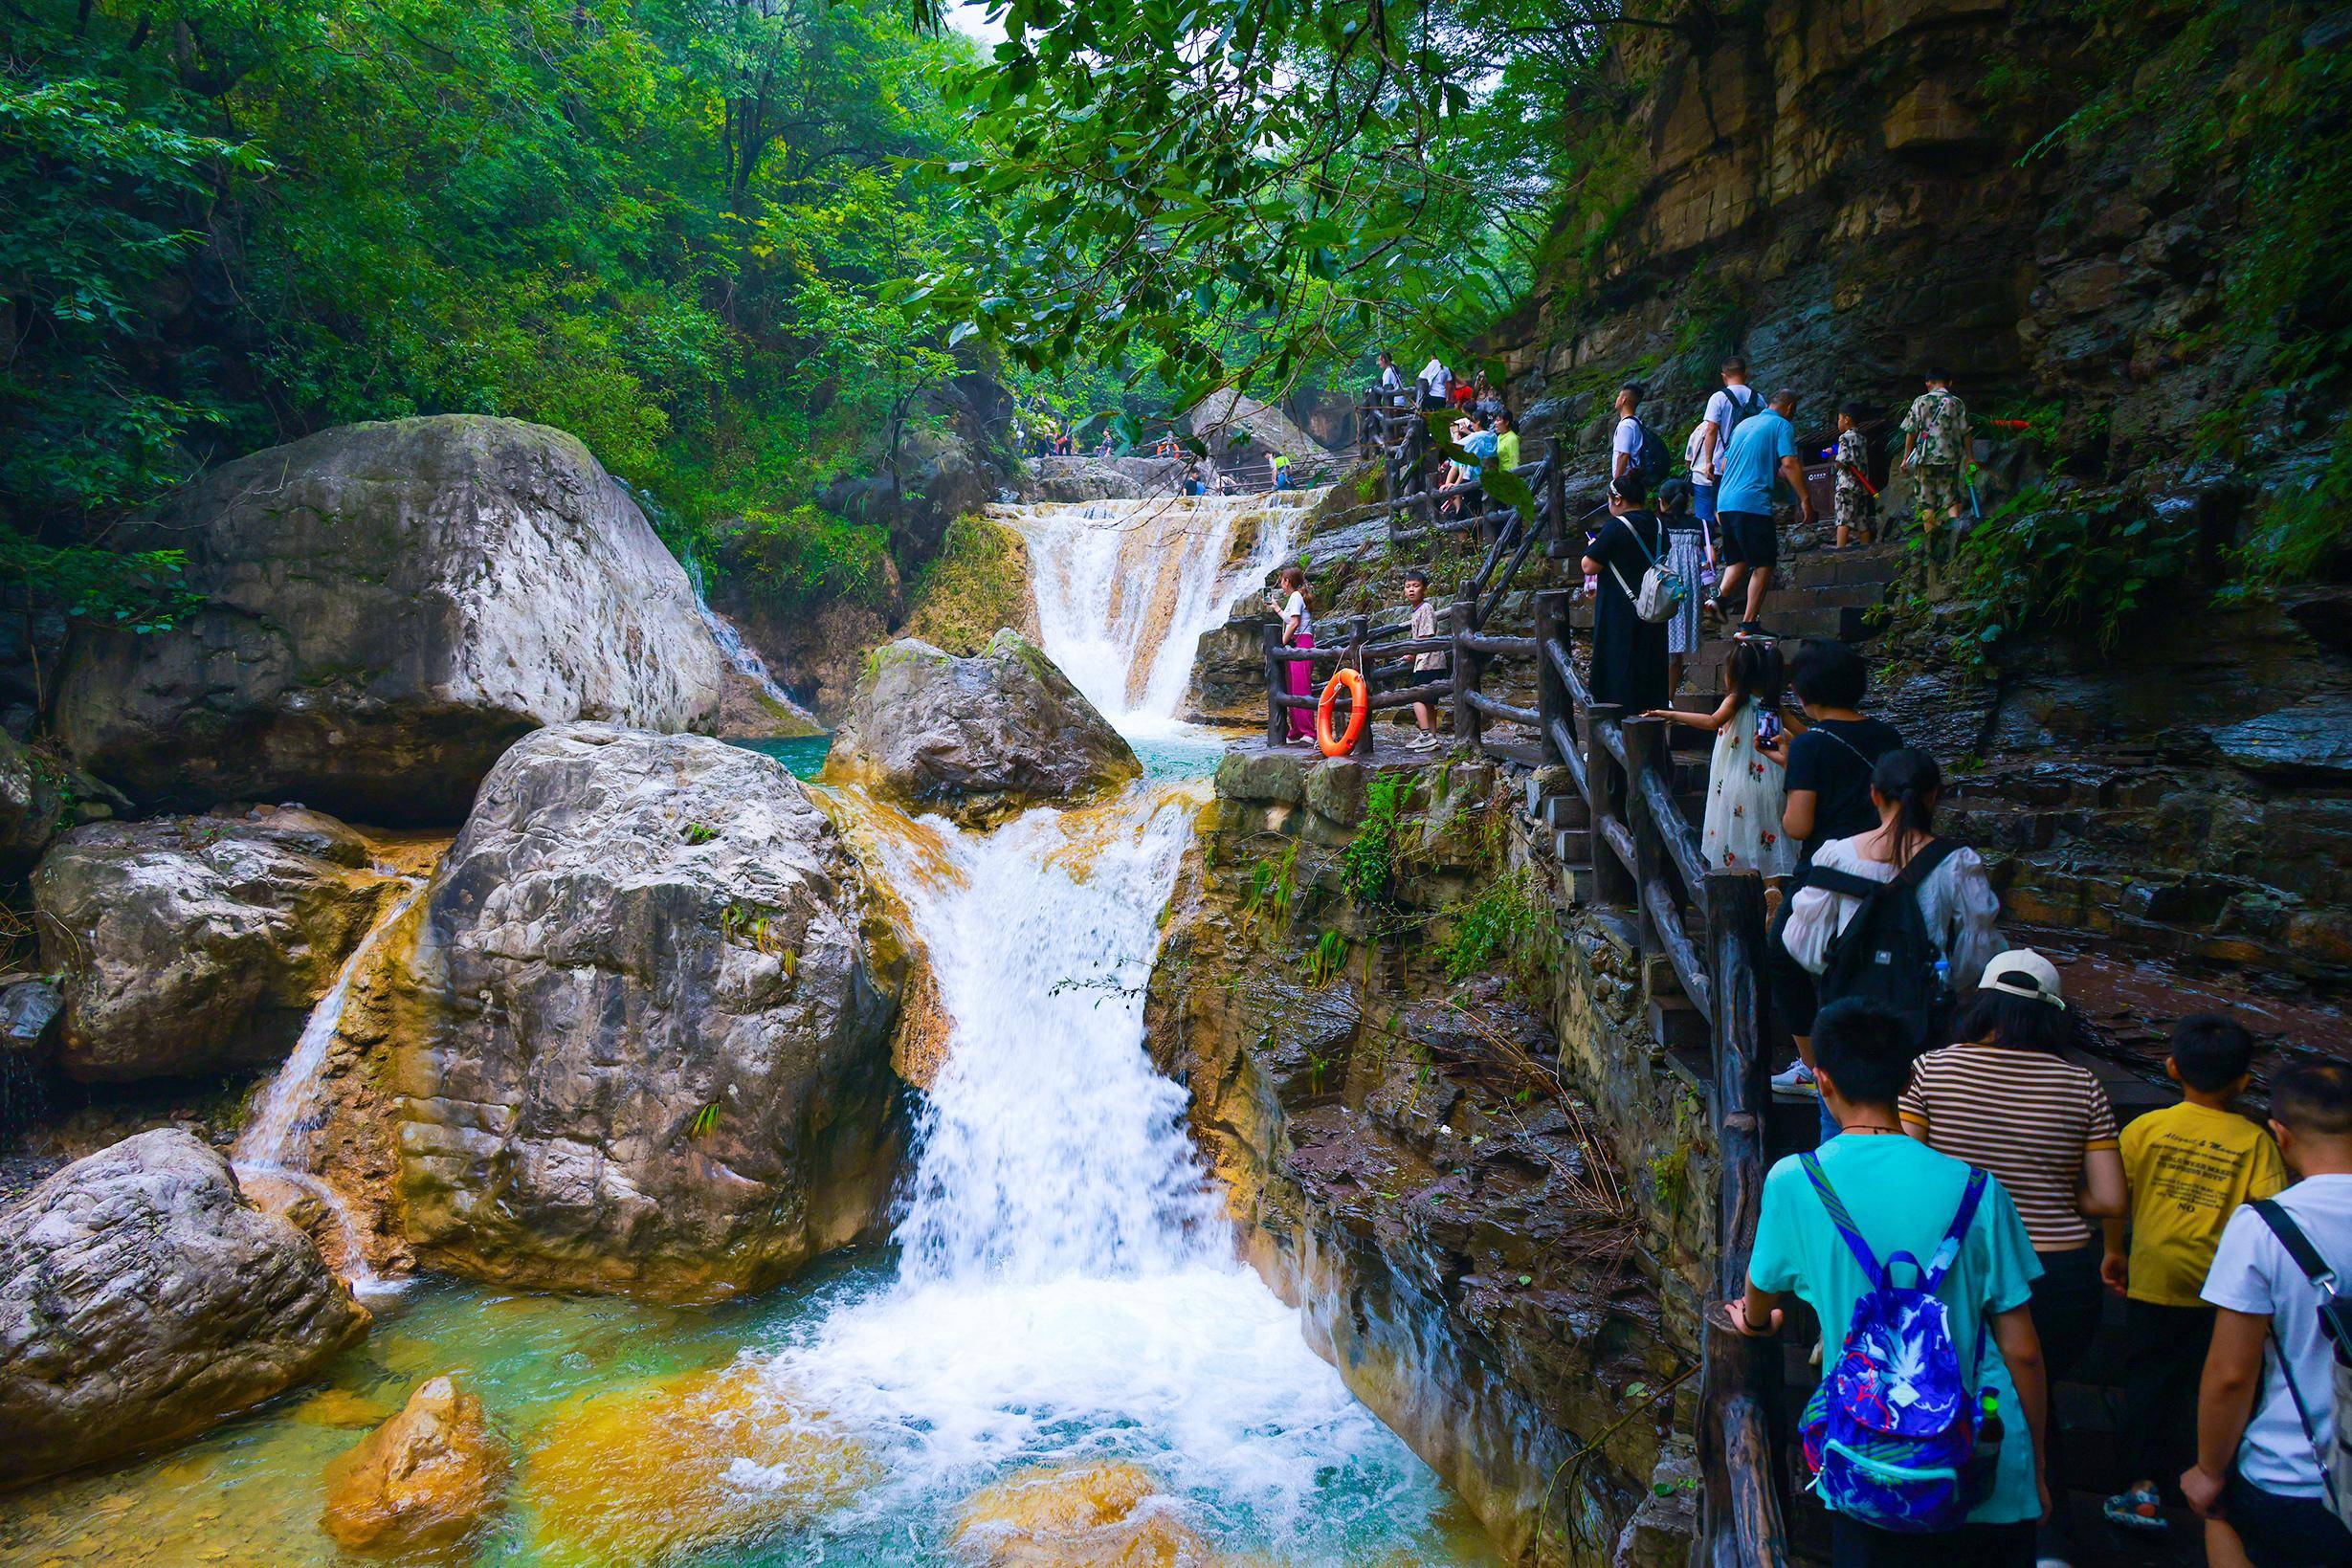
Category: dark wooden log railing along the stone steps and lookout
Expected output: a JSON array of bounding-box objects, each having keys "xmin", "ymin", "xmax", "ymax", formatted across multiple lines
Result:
[{"xmin": 1265, "ymin": 381, "xmax": 1787, "ymax": 1568}]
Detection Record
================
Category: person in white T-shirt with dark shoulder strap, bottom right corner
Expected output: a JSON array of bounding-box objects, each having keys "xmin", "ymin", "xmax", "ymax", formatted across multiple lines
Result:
[{"xmin": 2181, "ymin": 1063, "xmax": 2352, "ymax": 1568}]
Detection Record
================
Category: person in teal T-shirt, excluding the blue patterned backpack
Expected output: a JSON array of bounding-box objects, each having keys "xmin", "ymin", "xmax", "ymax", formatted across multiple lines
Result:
[{"xmin": 1726, "ymin": 1001, "xmax": 2049, "ymax": 1568}]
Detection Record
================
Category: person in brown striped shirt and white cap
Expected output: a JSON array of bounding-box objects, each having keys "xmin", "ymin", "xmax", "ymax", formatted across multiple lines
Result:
[{"xmin": 1898, "ymin": 947, "xmax": 2126, "ymax": 1563}]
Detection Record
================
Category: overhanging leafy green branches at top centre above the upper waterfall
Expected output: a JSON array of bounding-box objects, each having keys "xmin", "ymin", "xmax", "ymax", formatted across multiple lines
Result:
[{"xmin": 918, "ymin": 0, "xmax": 1621, "ymax": 413}]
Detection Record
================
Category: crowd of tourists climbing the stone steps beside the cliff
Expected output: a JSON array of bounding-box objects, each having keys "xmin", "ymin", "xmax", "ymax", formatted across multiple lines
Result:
[{"xmin": 1326, "ymin": 353, "xmax": 2352, "ymax": 1568}]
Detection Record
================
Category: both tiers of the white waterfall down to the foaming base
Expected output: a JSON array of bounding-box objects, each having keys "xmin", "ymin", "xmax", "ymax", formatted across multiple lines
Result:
[{"xmin": 743, "ymin": 484, "xmax": 1458, "ymax": 1568}]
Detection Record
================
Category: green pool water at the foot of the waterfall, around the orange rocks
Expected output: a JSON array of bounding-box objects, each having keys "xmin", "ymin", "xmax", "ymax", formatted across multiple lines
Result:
[{"xmin": 0, "ymin": 1253, "xmax": 1500, "ymax": 1568}]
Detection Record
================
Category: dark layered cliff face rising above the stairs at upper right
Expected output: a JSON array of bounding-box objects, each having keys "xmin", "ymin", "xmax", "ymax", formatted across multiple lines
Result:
[{"xmin": 1496, "ymin": 0, "xmax": 2352, "ymax": 992}]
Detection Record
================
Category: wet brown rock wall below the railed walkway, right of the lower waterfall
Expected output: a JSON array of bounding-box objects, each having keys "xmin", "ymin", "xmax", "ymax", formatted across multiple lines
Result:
[{"xmin": 1145, "ymin": 747, "xmax": 1698, "ymax": 1563}]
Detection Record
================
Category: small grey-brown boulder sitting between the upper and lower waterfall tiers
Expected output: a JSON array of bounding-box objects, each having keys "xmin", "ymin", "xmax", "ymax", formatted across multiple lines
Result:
[{"xmin": 826, "ymin": 628, "xmax": 1141, "ymax": 823}]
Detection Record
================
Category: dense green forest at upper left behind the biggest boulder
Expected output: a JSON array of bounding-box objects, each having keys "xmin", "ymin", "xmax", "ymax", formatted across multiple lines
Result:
[{"xmin": 0, "ymin": 0, "xmax": 971, "ymax": 613}]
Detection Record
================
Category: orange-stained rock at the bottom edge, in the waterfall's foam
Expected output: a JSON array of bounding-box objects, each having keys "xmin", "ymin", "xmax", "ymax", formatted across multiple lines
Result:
[{"xmin": 952, "ymin": 1462, "xmax": 1232, "ymax": 1568}]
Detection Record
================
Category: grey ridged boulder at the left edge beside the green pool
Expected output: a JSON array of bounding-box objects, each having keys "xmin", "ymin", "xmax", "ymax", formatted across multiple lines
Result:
[{"xmin": 0, "ymin": 1131, "xmax": 366, "ymax": 1484}]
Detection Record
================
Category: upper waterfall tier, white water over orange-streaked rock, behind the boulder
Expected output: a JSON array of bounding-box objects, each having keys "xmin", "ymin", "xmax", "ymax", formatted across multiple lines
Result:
[{"xmin": 997, "ymin": 492, "xmax": 1321, "ymax": 734}]
